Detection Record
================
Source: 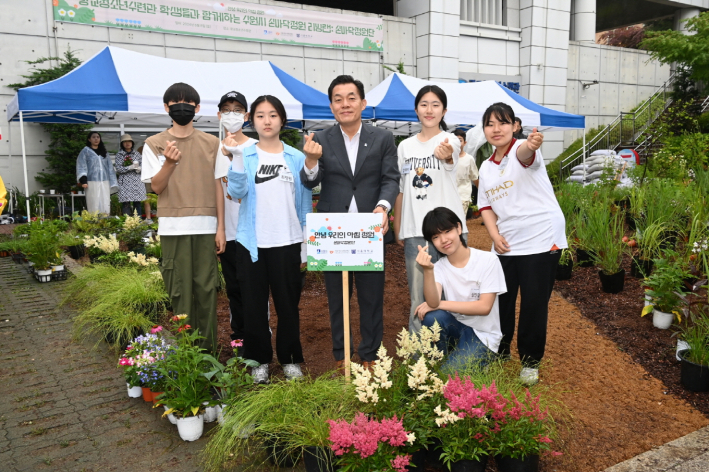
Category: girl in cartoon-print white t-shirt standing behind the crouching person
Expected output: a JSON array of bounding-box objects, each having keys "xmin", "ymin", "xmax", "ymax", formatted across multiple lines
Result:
[{"xmin": 394, "ymin": 85, "xmax": 467, "ymax": 333}]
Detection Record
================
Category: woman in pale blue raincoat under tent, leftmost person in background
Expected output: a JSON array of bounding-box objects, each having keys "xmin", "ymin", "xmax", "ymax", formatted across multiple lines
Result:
[{"xmin": 76, "ymin": 131, "xmax": 118, "ymax": 215}]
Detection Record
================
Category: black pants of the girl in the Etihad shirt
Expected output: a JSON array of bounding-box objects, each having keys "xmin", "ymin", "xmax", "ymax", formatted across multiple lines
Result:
[{"xmin": 498, "ymin": 251, "xmax": 561, "ymax": 367}]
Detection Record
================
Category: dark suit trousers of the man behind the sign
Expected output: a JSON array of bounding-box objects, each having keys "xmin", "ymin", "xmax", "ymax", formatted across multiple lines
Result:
[{"xmin": 325, "ymin": 271, "xmax": 384, "ymax": 361}]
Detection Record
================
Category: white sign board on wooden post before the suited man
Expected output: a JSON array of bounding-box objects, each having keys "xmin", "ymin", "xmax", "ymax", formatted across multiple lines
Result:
[{"xmin": 306, "ymin": 213, "xmax": 384, "ymax": 271}]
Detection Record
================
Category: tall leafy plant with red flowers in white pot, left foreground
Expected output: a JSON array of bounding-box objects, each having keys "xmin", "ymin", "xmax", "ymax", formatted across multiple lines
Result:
[{"xmin": 157, "ymin": 315, "xmax": 224, "ymax": 441}]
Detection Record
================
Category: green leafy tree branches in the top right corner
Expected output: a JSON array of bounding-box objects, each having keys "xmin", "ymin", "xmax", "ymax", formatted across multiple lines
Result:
[{"xmin": 640, "ymin": 12, "xmax": 709, "ymax": 80}]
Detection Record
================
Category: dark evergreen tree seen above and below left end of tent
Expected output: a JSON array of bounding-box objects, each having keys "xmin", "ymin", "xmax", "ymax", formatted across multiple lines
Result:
[{"xmin": 8, "ymin": 50, "xmax": 93, "ymax": 193}]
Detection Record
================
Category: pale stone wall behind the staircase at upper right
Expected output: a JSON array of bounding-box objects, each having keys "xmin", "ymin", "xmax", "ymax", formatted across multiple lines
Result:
[{"xmin": 564, "ymin": 41, "xmax": 670, "ymax": 148}]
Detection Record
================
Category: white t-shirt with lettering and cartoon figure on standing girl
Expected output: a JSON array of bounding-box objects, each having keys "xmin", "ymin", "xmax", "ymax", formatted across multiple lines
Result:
[{"xmin": 398, "ymin": 132, "xmax": 465, "ymax": 239}]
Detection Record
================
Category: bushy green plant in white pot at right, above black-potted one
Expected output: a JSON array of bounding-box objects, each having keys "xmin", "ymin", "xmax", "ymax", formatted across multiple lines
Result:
[{"xmin": 642, "ymin": 250, "xmax": 688, "ymax": 329}]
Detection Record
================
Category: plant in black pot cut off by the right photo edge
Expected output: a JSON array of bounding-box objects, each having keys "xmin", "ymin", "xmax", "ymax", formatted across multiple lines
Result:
[{"xmin": 679, "ymin": 307, "xmax": 709, "ymax": 392}]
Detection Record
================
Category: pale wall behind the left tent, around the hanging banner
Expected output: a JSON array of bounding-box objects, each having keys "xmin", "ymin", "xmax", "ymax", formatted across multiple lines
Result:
[{"xmin": 0, "ymin": 0, "xmax": 417, "ymax": 192}]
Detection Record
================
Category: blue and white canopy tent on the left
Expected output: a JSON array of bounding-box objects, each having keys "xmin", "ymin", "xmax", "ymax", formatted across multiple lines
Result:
[{"xmin": 7, "ymin": 46, "xmax": 334, "ymax": 215}]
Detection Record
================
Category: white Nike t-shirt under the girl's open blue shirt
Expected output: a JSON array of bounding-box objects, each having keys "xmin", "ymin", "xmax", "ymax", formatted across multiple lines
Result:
[{"xmin": 255, "ymin": 146, "xmax": 303, "ymax": 248}]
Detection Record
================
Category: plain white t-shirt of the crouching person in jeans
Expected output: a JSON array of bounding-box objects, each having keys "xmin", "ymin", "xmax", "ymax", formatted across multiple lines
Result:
[{"xmin": 433, "ymin": 248, "xmax": 507, "ymax": 352}]
